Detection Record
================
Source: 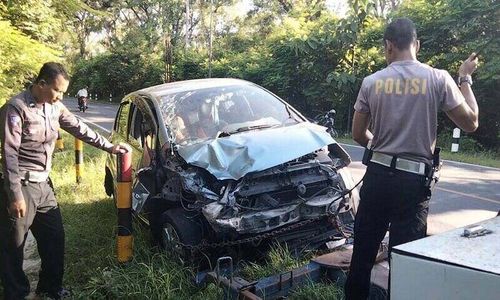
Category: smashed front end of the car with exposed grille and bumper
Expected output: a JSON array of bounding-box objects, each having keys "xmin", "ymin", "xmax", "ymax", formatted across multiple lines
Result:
[{"xmin": 202, "ymin": 162, "xmax": 358, "ymax": 234}]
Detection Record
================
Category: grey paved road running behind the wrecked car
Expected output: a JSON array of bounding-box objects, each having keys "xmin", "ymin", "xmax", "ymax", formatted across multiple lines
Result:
[{"xmin": 65, "ymin": 98, "xmax": 500, "ymax": 234}]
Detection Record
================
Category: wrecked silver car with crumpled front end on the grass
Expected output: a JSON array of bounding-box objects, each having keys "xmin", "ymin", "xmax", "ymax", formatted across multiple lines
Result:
[{"xmin": 105, "ymin": 79, "xmax": 358, "ymax": 258}]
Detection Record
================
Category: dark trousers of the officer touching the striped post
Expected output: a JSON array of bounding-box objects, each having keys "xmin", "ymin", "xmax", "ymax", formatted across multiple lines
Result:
[{"xmin": 0, "ymin": 181, "xmax": 64, "ymax": 299}]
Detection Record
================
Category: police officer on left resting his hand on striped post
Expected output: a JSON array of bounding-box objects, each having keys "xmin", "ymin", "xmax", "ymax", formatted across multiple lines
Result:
[{"xmin": 0, "ymin": 62, "xmax": 127, "ymax": 299}]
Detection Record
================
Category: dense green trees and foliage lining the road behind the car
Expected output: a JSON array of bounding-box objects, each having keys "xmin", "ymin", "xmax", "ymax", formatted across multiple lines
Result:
[{"xmin": 0, "ymin": 0, "xmax": 500, "ymax": 149}]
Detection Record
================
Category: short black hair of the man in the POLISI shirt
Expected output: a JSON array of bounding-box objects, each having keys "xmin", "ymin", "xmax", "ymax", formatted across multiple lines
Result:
[{"xmin": 384, "ymin": 18, "xmax": 417, "ymax": 50}]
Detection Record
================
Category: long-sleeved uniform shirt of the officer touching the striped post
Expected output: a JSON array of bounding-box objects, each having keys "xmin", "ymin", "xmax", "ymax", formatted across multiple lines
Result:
[{"xmin": 0, "ymin": 88, "xmax": 113, "ymax": 201}]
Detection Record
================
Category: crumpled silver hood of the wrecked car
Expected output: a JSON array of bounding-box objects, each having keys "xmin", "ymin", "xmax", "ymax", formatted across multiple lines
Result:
[{"xmin": 178, "ymin": 122, "xmax": 336, "ymax": 180}]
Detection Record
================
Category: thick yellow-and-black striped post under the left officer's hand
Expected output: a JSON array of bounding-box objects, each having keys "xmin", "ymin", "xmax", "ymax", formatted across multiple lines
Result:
[{"xmin": 116, "ymin": 150, "xmax": 133, "ymax": 262}]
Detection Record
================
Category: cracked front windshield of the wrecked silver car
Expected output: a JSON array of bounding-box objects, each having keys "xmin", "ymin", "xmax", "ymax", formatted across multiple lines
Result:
[{"xmin": 160, "ymin": 85, "xmax": 302, "ymax": 145}]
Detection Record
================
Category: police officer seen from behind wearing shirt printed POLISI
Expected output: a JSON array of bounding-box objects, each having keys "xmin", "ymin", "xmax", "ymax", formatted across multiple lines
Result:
[{"xmin": 345, "ymin": 18, "xmax": 479, "ymax": 299}]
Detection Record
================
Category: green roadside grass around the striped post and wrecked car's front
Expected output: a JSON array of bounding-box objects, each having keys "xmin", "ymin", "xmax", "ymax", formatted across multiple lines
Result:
[{"xmin": 27, "ymin": 134, "xmax": 341, "ymax": 300}]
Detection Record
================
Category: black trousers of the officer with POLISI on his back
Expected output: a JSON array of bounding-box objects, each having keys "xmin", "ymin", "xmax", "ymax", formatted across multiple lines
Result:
[{"xmin": 345, "ymin": 163, "xmax": 430, "ymax": 300}]
